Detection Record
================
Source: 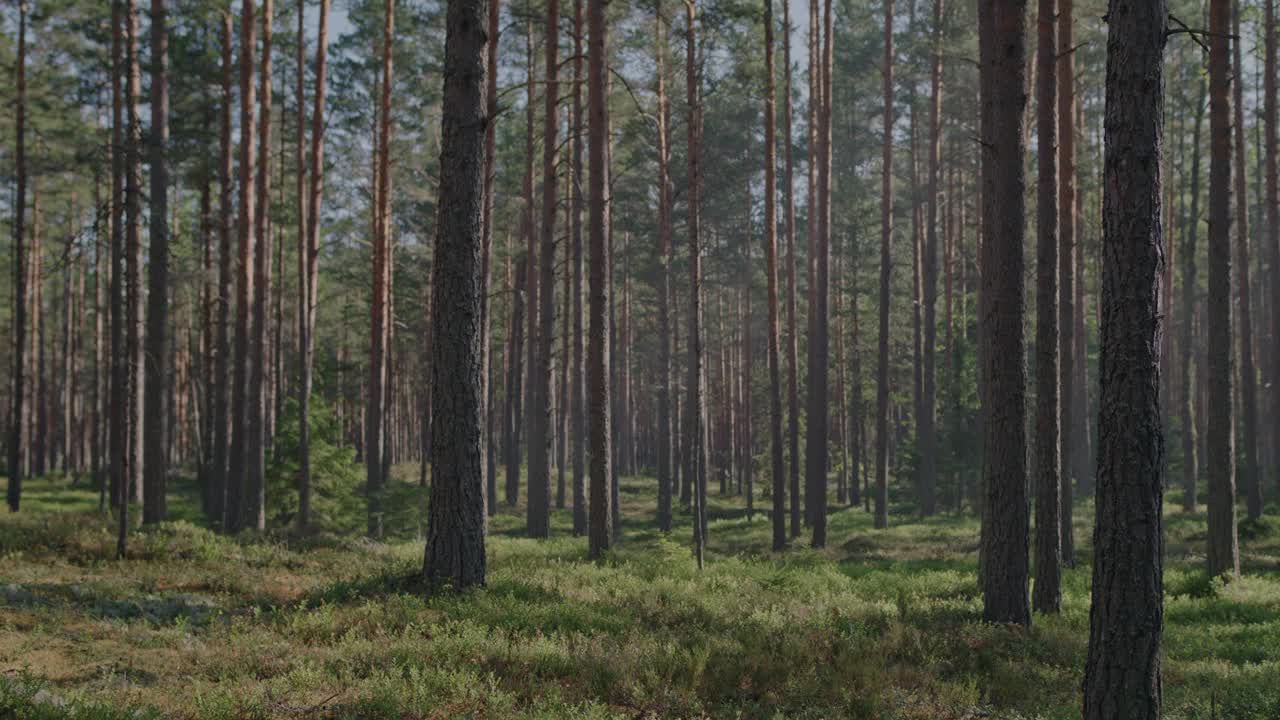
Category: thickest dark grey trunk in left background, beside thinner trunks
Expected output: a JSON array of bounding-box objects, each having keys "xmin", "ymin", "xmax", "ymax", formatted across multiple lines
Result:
[{"xmin": 142, "ymin": 0, "xmax": 172, "ymax": 524}]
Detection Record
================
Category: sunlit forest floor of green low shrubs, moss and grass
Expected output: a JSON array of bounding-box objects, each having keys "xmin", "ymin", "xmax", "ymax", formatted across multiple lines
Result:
[{"xmin": 0, "ymin": 471, "xmax": 1280, "ymax": 720}]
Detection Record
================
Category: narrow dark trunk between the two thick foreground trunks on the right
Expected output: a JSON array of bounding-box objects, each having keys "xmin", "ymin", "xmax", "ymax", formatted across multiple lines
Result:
[{"xmin": 1032, "ymin": 0, "xmax": 1062, "ymax": 612}]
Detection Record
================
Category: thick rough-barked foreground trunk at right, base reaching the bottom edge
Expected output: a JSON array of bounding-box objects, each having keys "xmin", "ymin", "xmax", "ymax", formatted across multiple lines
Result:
[{"xmin": 1083, "ymin": 0, "xmax": 1167, "ymax": 720}]
